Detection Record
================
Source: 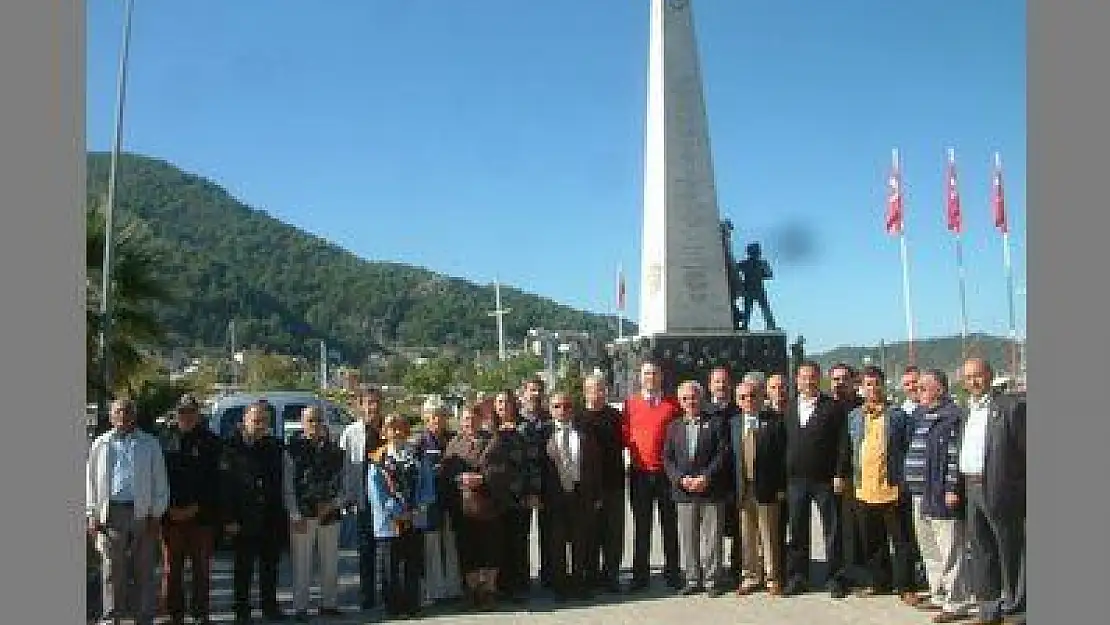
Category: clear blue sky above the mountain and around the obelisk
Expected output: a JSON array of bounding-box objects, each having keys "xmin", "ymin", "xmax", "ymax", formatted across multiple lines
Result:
[{"xmin": 87, "ymin": 0, "xmax": 1026, "ymax": 350}]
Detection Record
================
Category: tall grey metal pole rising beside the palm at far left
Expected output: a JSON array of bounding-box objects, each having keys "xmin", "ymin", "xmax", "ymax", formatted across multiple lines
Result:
[{"xmin": 97, "ymin": 0, "xmax": 134, "ymax": 432}]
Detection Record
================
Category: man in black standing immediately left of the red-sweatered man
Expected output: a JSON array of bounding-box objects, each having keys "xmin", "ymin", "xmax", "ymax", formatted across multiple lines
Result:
[{"xmin": 582, "ymin": 375, "xmax": 627, "ymax": 593}]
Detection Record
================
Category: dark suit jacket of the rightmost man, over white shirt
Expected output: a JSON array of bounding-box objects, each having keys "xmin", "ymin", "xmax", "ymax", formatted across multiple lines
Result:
[{"xmin": 982, "ymin": 393, "xmax": 1026, "ymax": 517}]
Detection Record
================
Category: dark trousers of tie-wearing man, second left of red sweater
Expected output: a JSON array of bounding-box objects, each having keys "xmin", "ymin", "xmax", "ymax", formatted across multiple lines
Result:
[{"xmin": 547, "ymin": 492, "xmax": 597, "ymax": 594}]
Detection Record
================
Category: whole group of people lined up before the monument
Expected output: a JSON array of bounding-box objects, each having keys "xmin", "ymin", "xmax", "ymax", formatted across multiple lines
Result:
[{"xmin": 87, "ymin": 359, "xmax": 1026, "ymax": 625}]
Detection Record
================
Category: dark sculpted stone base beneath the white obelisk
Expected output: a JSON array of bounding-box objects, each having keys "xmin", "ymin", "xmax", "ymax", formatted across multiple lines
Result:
[{"xmin": 611, "ymin": 332, "xmax": 790, "ymax": 399}]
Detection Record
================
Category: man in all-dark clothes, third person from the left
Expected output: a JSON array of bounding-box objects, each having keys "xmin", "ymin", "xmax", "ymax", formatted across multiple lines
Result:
[{"xmin": 220, "ymin": 402, "xmax": 286, "ymax": 623}]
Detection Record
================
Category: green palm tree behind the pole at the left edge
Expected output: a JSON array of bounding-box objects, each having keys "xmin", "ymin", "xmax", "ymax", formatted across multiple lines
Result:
[{"xmin": 85, "ymin": 202, "xmax": 171, "ymax": 406}]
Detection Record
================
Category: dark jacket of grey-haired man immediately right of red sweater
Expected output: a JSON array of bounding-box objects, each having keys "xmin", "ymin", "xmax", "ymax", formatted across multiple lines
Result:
[{"xmin": 663, "ymin": 413, "xmax": 729, "ymax": 503}]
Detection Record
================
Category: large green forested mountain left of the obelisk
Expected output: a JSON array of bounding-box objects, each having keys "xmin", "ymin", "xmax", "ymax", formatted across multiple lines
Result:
[{"xmin": 87, "ymin": 153, "xmax": 635, "ymax": 363}]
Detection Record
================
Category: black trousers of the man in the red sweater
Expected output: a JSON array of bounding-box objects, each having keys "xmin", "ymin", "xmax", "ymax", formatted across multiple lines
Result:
[{"xmin": 628, "ymin": 471, "xmax": 683, "ymax": 583}]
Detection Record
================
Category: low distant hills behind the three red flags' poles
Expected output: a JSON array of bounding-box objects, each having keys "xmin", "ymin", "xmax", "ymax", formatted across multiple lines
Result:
[{"xmin": 810, "ymin": 334, "xmax": 1010, "ymax": 375}]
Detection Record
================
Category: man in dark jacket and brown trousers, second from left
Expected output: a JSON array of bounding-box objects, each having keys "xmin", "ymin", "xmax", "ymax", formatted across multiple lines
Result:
[{"xmin": 161, "ymin": 395, "xmax": 221, "ymax": 625}]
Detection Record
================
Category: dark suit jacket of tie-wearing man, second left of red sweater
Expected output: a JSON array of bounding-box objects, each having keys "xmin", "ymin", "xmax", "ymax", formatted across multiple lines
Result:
[{"xmin": 543, "ymin": 419, "xmax": 603, "ymax": 513}]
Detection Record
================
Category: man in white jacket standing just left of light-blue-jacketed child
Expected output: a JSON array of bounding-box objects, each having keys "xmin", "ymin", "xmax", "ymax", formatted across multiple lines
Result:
[{"xmin": 340, "ymin": 387, "xmax": 382, "ymax": 611}]
